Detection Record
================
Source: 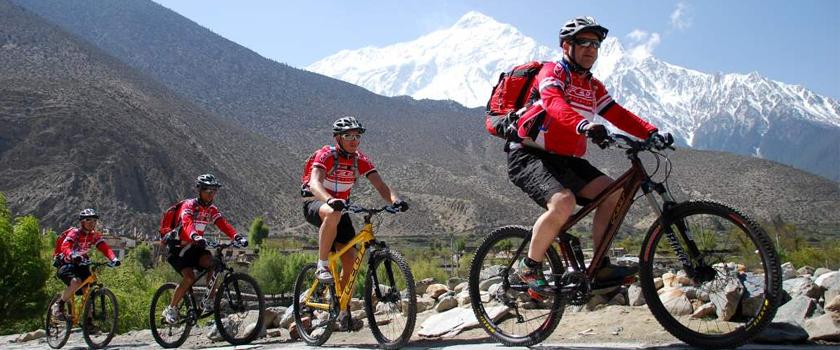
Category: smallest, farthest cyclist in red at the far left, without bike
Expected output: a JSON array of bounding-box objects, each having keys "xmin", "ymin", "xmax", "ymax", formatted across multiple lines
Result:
[{"xmin": 52, "ymin": 208, "xmax": 120, "ymax": 319}]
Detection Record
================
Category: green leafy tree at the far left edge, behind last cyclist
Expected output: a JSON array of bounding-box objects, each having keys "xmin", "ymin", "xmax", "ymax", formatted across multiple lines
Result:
[{"xmin": 0, "ymin": 194, "xmax": 50, "ymax": 333}]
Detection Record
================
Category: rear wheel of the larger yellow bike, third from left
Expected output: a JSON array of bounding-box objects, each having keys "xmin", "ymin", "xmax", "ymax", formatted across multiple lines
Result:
[{"xmin": 292, "ymin": 264, "xmax": 338, "ymax": 346}]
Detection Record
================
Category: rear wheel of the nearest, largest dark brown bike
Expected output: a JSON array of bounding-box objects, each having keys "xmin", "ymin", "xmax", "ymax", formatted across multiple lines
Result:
[{"xmin": 469, "ymin": 226, "xmax": 565, "ymax": 346}]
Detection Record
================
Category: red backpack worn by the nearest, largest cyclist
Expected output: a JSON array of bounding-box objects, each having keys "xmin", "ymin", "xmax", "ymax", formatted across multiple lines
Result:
[{"xmin": 484, "ymin": 61, "xmax": 543, "ymax": 139}]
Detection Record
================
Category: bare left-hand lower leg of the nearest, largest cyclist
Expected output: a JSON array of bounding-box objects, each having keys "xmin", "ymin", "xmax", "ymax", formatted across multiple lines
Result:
[{"xmin": 528, "ymin": 189, "xmax": 575, "ymax": 262}]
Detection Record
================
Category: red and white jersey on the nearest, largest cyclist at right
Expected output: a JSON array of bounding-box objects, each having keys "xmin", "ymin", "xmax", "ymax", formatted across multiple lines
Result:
[{"xmin": 518, "ymin": 61, "xmax": 656, "ymax": 157}]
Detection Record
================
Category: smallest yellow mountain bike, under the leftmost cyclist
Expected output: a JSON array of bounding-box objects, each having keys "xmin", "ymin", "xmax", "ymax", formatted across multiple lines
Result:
[{"xmin": 44, "ymin": 262, "xmax": 119, "ymax": 349}]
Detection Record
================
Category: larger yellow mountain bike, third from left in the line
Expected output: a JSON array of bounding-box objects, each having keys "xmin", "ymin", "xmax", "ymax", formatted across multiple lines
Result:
[{"xmin": 294, "ymin": 204, "xmax": 417, "ymax": 349}]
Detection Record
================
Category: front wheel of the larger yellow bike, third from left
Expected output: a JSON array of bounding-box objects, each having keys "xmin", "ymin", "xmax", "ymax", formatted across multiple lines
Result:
[{"xmin": 364, "ymin": 250, "xmax": 417, "ymax": 349}]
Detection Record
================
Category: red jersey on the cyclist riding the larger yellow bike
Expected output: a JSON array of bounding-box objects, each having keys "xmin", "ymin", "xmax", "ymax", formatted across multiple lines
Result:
[{"xmin": 312, "ymin": 146, "xmax": 376, "ymax": 200}]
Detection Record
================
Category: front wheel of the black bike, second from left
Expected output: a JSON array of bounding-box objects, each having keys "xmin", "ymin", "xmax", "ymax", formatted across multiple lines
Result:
[{"xmin": 213, "ymin": 273, "xmax": 265, "ymax": 345}]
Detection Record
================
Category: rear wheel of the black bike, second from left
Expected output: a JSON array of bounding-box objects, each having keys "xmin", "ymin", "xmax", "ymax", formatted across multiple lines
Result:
[{"xmin": 149, "ymin": 282, "xmax": 197, "ymax": 348}]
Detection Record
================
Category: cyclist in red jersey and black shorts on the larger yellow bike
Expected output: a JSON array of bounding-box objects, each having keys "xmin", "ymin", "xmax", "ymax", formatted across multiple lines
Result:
[{"xmin": 301, "ymin": 116, "xmax": 408, "ymax": 290}]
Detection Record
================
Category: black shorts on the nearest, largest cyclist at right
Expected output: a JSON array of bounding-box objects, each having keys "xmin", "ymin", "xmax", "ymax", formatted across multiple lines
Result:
[{"xmin": 508, "ymin": 147, "xmax": 604, "ymax": 208}]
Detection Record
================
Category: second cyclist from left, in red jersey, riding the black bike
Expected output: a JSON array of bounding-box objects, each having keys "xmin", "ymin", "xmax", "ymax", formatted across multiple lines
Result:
[{"xmin": 163, "ymin": 174, "xmax": 248, "ymax": 323}]
